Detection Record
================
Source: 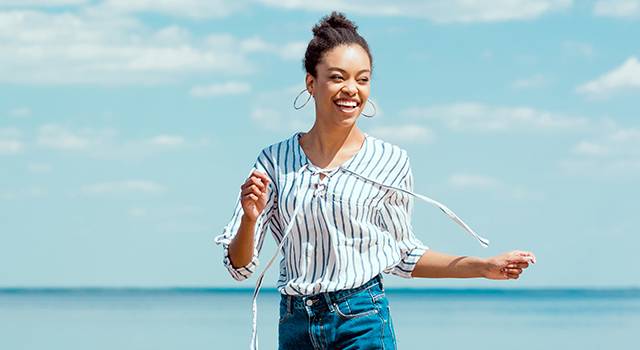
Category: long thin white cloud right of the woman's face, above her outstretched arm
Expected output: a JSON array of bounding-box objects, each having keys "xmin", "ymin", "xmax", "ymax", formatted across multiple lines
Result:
[{"xmin": 403, "ymin": 103, "xmax": 589, "ymax": 132}]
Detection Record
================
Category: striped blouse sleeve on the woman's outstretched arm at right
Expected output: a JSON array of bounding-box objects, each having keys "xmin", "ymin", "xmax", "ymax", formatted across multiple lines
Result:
[{"xmin": 380, "ymin": 153, "xmax": 429, "ymax": 278}]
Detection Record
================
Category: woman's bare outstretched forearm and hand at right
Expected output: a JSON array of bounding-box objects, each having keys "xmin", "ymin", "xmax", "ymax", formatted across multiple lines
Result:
[{"xmin": 411, "ymin": 249, "xmax": 536, "ymax": 279}]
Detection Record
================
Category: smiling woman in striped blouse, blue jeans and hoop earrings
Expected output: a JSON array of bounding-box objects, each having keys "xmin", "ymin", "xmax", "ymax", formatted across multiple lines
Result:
[{"xmin": 216, "ymin": 12, "xmax": 535, "ymax": 349}]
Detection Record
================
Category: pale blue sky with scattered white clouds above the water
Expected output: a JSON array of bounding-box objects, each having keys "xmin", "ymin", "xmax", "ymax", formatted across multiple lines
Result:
[{"xmin": 0, "ymin": 0, "xmax": 640, "ymax": 287}]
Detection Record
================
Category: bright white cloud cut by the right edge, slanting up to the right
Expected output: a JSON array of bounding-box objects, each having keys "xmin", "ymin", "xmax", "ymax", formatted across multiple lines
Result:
[{"xmin": 576, "ymin": 57, "xmax": 640, "ymax": 95}]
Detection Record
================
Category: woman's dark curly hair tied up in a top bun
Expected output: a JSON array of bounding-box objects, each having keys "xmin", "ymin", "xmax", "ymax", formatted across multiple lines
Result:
[{"xmin": 303, "ymin": 11, "xmax": 373, "ymax": 78}]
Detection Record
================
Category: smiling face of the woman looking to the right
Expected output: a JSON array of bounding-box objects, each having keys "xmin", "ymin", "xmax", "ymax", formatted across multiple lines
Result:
[{"xmin": 306, "ymin": 44, "xmax": 371, "ymax": 126}]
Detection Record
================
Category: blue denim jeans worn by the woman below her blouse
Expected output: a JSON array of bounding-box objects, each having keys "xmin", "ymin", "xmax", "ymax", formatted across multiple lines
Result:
[{"xmin": 278, "ymin": 275, "xmax": 397, "ymax": 350}]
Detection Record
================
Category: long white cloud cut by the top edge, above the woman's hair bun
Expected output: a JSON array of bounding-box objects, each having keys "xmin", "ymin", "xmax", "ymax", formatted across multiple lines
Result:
[{"xmin": 259, "ymin": 0, "xmax": 572, "ymax": 23}]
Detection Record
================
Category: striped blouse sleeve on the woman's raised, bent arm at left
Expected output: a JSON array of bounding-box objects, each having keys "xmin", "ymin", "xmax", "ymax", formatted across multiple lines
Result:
[{"xmin": 214, "ymin": 149, "xmax": 279, "ymax": 281}]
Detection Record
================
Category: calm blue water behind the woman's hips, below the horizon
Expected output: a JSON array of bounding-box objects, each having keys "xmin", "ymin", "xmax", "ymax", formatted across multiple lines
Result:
[{"xmin": 0, "ymin": 289, "xmax": 640, "ymax": 350}]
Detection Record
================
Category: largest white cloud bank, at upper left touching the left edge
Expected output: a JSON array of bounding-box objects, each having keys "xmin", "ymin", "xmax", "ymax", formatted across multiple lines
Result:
[{"xmin": 0, "ymin": 11, "xmax": 254, "ymax": 84}]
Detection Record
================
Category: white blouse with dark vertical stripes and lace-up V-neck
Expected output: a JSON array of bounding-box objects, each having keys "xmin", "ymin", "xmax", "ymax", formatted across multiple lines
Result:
[{"xmin": 215, "ymin": 132, "xmax": 429, "ymax": 295}]
